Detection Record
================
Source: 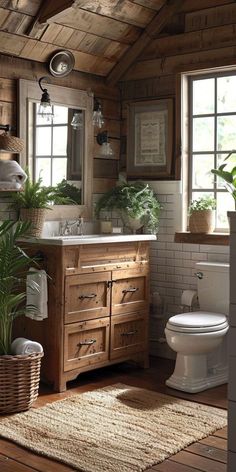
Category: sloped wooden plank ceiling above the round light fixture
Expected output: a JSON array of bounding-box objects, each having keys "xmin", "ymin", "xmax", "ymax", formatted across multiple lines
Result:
[{"xmin": 0, "ymin": 0, "xmax": 234, "ymax": 83}]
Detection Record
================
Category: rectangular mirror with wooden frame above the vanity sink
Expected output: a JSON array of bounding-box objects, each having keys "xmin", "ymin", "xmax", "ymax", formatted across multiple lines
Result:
[{"xmin": 19, "ymin": 80, "xmax": 93, "ymax": 217}]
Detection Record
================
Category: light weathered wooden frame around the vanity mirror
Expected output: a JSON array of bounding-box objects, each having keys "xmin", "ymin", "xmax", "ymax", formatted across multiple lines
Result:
[{"xmin": 18, "ymin": 79, "xmax": 93, "ymax": 220}]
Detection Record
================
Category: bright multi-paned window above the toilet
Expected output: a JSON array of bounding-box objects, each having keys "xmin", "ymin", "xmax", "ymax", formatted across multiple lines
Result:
[{"xmin": 189, "ymin": 73, "xmax": 236, "ymax": 231}]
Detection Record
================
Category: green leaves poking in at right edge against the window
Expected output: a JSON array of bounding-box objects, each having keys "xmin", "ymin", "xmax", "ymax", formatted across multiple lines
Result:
[{"xmin": 211, "ymin": 150, "xmax": 236, "ymax": 205}]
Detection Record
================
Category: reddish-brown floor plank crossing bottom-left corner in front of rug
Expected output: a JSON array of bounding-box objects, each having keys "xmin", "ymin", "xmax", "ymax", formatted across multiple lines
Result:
[{"xmin": 0, "ymin": 439, "xmax": 75, "ymax": 472}]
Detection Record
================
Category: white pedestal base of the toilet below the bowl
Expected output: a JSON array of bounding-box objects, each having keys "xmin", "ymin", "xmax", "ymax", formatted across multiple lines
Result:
[{"xmin": 166, "ymin": 354, "xmax": 228, "ymax": 393}]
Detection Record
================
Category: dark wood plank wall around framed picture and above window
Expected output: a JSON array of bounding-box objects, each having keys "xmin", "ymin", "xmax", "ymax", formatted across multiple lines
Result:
[{"xmin": 121, "ymin": 0, "xmax": 236, "ymax": 179}]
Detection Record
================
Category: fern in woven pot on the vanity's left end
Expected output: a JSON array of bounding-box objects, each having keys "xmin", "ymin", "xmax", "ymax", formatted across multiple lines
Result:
[{"xmin": 11, "ymin": 170, "xmax": 71, "ymax": 237}]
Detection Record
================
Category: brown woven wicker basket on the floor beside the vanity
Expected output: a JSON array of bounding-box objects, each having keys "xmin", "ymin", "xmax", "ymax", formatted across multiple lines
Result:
[{"xmin": 0, "ymin": 352, "xmax": 43, "ymax": 415}]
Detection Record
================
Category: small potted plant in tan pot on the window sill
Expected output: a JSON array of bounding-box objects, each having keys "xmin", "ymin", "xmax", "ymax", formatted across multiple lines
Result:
[{"xmin": 188, "ymin": 195, "xmax": 216, "ymax": 233}]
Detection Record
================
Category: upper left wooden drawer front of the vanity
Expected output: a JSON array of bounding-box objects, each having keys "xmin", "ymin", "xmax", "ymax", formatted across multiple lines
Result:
[{"xmin": 65, "ymin": 272, "xmax": 111, "ymax": 323}]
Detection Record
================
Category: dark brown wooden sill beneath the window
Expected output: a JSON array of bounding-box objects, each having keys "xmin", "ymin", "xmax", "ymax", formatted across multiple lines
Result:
[{"xmin": 175, "ymin": 231, "xmax": 229, "ymax": 246}]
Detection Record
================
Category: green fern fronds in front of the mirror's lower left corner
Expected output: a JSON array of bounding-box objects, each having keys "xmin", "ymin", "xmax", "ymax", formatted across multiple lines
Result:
[{"xmin": 11, "ymin": 169, "xmax": 71, "ymax": 210}]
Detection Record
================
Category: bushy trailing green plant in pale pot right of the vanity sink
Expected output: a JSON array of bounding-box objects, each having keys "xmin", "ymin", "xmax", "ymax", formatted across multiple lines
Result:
[{"xmin": 95, "ymin": 178, "xmax": 162, "ymax": 233}]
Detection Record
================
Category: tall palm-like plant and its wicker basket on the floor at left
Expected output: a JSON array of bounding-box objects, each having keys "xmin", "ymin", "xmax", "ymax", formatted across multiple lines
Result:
[{"xmin": 0, "ymin": 220, "xmax": 43, "ymax": 414}]
